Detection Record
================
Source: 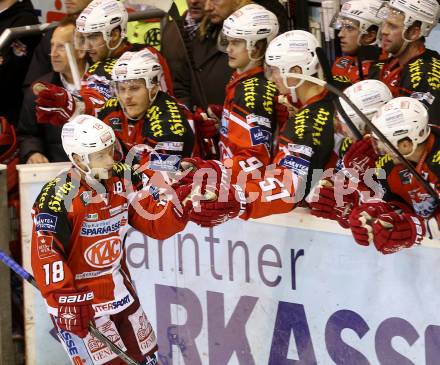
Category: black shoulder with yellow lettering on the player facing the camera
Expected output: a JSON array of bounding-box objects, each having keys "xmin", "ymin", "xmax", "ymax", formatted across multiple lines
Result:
[{"xmin": 144, "ymin": 91, "xmax": 191, "ymax": 139}]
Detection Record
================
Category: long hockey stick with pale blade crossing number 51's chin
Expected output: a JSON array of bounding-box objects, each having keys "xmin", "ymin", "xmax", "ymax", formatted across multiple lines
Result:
[{"xmin": 287, "ymin": 62, "xmax": 440, "ymax": 206}]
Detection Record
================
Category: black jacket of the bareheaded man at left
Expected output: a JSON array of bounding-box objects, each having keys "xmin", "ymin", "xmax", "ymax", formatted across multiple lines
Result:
[{"xmin": 17, "ymin": 72, "xmax": 69, "ymax": 163}]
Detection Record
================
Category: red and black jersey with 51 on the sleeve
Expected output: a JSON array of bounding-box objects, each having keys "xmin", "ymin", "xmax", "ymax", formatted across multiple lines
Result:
[{"xmin": 238, "ymin": 91, "xmax": 335, "ymax": 219}]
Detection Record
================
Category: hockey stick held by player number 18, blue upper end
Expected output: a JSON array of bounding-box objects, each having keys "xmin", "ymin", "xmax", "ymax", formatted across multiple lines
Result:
[{"xmin": 0, "ymin": 250, "xmax": 140, "ymax": 365}]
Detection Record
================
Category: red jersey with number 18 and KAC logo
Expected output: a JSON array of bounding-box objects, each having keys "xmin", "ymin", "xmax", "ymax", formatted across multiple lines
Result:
[{"xmin": 31, "ymin": 163, "xmax": 186, "ymax": 317}]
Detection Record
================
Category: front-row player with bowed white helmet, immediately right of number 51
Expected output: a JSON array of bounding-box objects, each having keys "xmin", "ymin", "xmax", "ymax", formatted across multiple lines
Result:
[{"xmin": 309, "ymin": 80, "xmax": 392, "ymax": 228}]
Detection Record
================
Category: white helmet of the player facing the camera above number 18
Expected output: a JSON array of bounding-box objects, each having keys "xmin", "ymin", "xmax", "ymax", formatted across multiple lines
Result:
[{"xmin": 112, "ymin": 49, "xmax": 163, "ymax": 89}]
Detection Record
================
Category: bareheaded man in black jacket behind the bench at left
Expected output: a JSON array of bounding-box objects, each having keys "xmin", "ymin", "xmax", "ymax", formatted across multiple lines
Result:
[{"xmin": 18, "ymin": 16, "xmax": 86, "ymax": 163}]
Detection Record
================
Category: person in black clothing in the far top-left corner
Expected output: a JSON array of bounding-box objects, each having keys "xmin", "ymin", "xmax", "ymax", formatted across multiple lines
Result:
[{"xmin": 0, "ymin": 0, "xmax": 40, "ymax": 125}]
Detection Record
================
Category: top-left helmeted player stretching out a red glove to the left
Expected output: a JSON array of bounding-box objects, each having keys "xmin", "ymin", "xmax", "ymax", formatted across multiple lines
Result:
[{"xmin": 36, "ymin": 0, "xmax": 173, "ymax": 125}]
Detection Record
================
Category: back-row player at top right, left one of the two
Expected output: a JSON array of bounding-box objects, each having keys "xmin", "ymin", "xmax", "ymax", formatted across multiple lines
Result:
[{"xmin": 330, "ymin": 0, "xmax": 384, "ymax": 89}]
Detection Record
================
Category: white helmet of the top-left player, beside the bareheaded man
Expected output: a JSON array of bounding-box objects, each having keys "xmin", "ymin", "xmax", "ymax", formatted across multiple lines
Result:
[{"xmin": 76, "ymin": 0, "xmax": 128, "ymax": 49}]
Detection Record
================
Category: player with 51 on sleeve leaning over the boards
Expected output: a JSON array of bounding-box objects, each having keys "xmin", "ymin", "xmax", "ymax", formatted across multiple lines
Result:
[{"xmin": 186, "ymin": 30, "xmax": 335, "ymax": 219}]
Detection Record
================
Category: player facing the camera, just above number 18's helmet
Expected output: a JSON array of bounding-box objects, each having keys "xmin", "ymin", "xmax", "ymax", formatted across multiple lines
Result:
[{"xmin": 98, "ymin": 49, "xmax": 195, "ymax": 172}]
